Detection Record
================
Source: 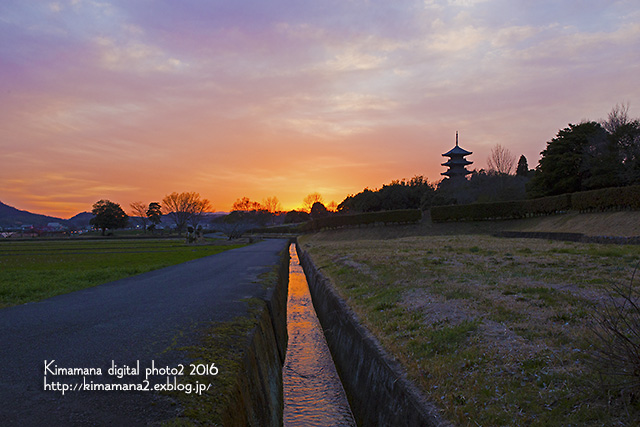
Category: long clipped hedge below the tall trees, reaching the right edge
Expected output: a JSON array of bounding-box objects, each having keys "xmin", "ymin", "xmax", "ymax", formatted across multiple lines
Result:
[{"xmin": 431, "ymin": 185, "xmax": 640, "ymax": 222}]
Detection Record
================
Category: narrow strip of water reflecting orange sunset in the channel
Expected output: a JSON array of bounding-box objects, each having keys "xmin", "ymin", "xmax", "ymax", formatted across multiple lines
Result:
[{"xmin": 283, "ymin": 245, "xmax": 356, "ymax": 427}]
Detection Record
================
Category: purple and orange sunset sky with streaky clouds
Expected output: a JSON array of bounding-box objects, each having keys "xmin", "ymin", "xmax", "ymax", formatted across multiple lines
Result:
[{"xmin": 0, "ymin": 0, "xmax": 640, "ymax": 218}]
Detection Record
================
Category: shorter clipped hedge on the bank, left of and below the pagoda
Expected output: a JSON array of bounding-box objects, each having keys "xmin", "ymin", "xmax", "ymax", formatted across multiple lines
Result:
[{"xmin": 303, "ymin": 209, "xmax": 422, "ymax": 231}]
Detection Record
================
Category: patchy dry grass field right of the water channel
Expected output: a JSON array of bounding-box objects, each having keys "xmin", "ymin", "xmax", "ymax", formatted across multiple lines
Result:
[{"xmin": 300, "ymin": 231, "xmax": 640, "ymax": 426}]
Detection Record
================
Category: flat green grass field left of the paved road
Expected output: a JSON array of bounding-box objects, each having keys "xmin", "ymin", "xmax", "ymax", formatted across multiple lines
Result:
[{"xmin": 0, "ymin": 239, "xmax": 242, "ymax": 308}]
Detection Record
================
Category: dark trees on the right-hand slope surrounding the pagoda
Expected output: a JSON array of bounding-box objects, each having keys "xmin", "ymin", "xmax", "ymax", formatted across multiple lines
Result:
[{"xmin": 338, "ymin": 104, "xmax": 640, "ymax": 212}]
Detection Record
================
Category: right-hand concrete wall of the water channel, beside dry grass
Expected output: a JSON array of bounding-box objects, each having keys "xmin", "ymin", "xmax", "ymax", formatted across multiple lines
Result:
[{"xmin": 296, "ymin": 245, "xmax": 451, "ymax": 426}]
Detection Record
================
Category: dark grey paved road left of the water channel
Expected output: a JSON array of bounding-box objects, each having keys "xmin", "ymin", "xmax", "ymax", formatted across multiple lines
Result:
[{"xmin": 0, "ymin": 240, "xmax": 288, "ymax": 426}]
